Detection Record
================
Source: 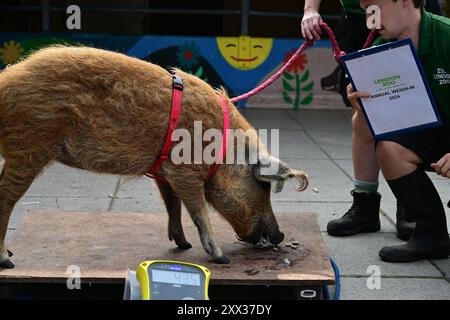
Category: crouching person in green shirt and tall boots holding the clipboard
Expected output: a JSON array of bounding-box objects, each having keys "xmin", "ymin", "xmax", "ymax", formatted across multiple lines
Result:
[{"xmin": 347, "ymin": 0, "xmax": 450, "ymax": 262}]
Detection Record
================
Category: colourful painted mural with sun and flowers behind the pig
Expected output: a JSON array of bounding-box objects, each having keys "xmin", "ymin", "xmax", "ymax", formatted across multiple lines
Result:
[{"xmin": 0, "ymin": 33, "xmax": 343, "ymax": 109}]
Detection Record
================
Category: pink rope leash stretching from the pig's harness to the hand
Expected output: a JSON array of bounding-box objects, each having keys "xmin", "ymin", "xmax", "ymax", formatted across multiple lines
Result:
[{"xmin": 231, "ymin": 22, "xmax": 377, "ymax": 103}]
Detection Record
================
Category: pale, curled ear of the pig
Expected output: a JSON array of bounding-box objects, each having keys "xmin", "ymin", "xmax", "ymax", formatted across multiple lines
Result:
[{"xmin": 253, "ymin": 157, "xmax": 308, "ymax": 193}]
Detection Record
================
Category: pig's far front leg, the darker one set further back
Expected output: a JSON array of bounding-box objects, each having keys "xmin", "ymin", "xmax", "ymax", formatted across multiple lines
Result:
[{"xmin": 156, "ymin": 180, "xmax": 192, "ymax": 250}]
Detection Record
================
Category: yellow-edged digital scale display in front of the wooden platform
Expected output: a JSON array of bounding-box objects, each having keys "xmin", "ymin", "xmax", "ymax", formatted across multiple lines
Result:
[{"xmin": 136, "ymin": 260, "xmax": 211, "ymax": 300}]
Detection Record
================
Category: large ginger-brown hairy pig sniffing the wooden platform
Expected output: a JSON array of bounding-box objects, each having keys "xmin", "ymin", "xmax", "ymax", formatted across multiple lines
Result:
[{"xmin": 0, "ymin": 46, "xmax": 308, "ymax": 268}]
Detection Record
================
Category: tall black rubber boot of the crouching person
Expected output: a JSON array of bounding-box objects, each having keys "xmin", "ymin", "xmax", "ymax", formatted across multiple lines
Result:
[{"xmin": 379, "ymin": 170, "xmax": 450, "ymax": 262}]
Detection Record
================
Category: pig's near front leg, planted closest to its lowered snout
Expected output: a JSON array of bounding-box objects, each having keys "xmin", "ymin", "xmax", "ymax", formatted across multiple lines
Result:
[{"xmin": 170, "ymin": 176, "xmax": 230, "ymax": 263}]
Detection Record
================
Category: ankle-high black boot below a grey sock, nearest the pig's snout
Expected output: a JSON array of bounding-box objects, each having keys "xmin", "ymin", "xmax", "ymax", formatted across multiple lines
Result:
[{"xmin": 327, "ymin": 190, "xmax": 381, "ymax": 237}]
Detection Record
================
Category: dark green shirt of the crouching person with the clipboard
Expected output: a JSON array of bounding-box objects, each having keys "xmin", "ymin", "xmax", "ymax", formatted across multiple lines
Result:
[{"xmin": 373, "ymin": 10, "xmax": 450, "ymax": 127}]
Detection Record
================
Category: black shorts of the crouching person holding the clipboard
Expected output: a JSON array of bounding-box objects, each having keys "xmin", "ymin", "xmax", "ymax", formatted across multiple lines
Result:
[{"xmin": 377, "ymin": 127, "xmax": 450, "ymax": 171}]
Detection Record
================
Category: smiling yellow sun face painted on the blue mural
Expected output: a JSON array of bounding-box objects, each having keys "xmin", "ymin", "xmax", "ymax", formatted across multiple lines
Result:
[{"xmin": 217, "ymin": 36, "xmax": 273, "ymax": 70}]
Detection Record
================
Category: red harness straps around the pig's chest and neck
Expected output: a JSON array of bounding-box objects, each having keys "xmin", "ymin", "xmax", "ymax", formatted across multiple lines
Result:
[{"xmin": 145, "ymin": 75, "xmax": 230, "ymax": 182}]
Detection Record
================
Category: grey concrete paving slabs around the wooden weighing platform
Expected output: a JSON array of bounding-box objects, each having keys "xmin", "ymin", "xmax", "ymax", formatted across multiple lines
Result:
[{"xmin": 4, "ymin": 109, "xmax": 450, "ymax": 300}]
